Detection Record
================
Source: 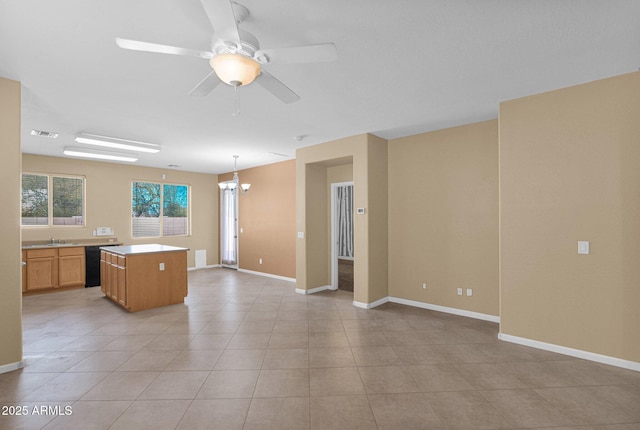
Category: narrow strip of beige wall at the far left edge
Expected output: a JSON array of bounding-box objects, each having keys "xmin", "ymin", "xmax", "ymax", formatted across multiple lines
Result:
[{"xmin": 0, "ymin": 78, "xmax": 22, "ymax": 370}]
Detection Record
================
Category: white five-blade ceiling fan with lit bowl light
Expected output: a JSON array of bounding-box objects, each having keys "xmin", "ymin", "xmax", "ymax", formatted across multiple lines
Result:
[{"xmin": 116, "ymin": 0, "xmax": 338, "ymax": 103}]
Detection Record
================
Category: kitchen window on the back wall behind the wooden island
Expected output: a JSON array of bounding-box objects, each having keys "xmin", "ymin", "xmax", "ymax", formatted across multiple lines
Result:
[{"xmin": 131, "ymin": 182, "xmax": 189, "ymax": 237}]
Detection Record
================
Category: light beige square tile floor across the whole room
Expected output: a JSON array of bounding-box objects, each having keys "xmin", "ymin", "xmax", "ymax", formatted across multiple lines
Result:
[{"xmin": 0, "ymin": 269, "xmax": 640, "ymax": 430}]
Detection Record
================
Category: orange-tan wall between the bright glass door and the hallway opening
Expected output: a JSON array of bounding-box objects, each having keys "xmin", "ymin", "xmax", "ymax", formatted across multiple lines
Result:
[{"xmin": 220, "ymin": 160, "xmax": 296, "ymax": 278}]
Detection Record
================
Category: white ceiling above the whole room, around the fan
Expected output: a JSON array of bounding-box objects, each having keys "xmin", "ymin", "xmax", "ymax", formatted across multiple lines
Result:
[{"xmin": 0, "ymin": 0, "xmax": 640, "ymax": 173}]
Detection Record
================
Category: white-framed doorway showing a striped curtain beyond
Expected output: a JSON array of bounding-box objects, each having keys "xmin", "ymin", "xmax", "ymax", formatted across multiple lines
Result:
[{"xmin": 331, "ymin": 181, "xmax": 355, "ymax": 291}]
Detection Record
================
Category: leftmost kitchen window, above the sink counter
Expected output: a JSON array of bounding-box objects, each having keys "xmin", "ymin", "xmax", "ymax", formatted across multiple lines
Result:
[{"xmin": 21, "ymin": 173, "xmax": 85, "ymax": 226}]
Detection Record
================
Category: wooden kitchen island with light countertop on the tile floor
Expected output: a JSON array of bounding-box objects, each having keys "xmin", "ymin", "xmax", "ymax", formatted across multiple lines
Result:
[{"xmin": 100, "ymin": 244, "xmax": 189, "ymax": 312}]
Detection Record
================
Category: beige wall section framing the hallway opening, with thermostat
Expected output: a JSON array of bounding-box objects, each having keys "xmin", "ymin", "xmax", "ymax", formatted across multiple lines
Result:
[{"xmin": 296, "ymin": 134, "xmax": 388, "ymax": 304}]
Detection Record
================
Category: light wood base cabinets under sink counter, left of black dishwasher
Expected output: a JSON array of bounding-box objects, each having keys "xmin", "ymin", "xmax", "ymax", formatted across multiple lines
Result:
[{"xmin": 22, "ymin": 246, "xmax": 85, "ymax": 293}]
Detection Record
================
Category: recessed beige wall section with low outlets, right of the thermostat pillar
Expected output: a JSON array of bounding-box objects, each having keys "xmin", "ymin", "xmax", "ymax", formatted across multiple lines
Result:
[{"xmin": 389, "ymin": 120, "xmax": 499, "ymax": 316}]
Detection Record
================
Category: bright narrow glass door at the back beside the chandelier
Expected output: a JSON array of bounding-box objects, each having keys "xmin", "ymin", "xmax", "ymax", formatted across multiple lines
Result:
[{"xmin": 220, "ymin": 181, "xmax": 238, "ymax": 269}]
